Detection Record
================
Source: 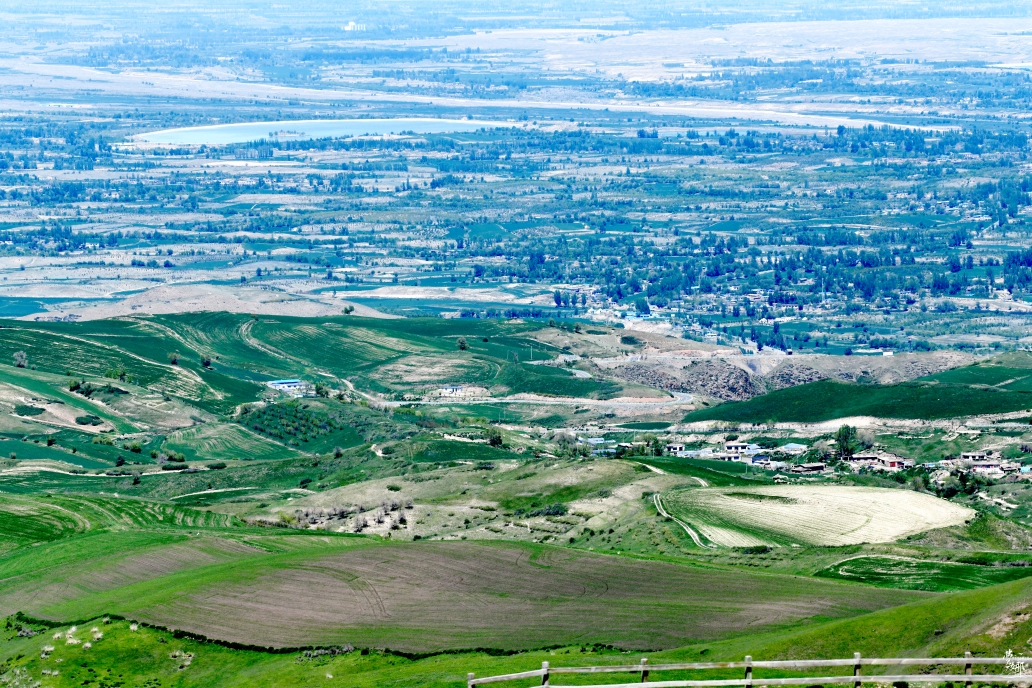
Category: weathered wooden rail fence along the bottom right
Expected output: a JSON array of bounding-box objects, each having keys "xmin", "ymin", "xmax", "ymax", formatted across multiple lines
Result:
[{"xmin": 466, "ymin": 652, "xmax": 1032, "ymax": 688}]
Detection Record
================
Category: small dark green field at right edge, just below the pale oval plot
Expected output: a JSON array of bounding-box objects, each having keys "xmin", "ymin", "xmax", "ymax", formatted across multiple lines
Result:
[{"xmin": 817, "ymin": 556, "xmax": 1032, "ymax": 592}]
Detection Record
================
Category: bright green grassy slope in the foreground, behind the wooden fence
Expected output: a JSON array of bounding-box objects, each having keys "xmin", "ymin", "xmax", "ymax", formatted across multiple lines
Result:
[{"xmin": 6, "ymin": 557, "xmax": 1032, "ymax": 688}]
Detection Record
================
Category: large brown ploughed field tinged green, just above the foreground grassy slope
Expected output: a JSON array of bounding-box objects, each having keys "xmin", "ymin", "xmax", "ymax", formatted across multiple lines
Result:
[{"xmin": 126, "ymin": 542, "xmax": 916, "ymax": 652}]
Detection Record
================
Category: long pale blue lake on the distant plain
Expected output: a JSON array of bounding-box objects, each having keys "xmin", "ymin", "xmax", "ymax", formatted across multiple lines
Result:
[{"xmin": 133, "ymin": 118, "xmax": 517, "ymax": 145}]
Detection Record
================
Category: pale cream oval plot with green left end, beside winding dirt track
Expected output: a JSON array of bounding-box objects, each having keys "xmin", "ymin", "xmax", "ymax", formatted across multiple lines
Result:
[{"xmin": 664, "ymin": 485, "xmax": 973, "ymax": 547}]
